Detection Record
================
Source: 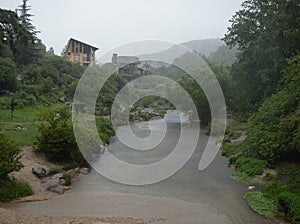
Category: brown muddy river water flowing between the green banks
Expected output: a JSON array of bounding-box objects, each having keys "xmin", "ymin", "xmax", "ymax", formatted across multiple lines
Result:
[{"xmin": 6, "ymin": 116, "xmax": 272, "ymax": 224}]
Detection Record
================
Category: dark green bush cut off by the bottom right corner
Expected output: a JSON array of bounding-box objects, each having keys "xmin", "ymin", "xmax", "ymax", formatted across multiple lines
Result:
[{"xmin": 278, "ymin": 191, "xmax": 300, "ymax": 222}]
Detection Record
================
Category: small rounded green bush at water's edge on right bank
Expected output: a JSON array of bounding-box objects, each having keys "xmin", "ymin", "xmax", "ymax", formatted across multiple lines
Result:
[{"xmin": 235, "ymin": 157, "xmax": 267, "ymax": 177}]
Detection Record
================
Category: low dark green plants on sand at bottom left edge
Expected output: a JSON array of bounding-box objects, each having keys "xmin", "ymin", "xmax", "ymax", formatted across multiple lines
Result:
[{"xmin": 0, "ymin": 179, "xmax": 33, "ymax": 201}]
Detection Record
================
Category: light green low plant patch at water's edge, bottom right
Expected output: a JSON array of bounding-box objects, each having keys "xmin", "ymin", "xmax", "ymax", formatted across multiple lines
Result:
[{"xmin": 244, "ymin": 192, "xmax": 277, "ymax": 218}]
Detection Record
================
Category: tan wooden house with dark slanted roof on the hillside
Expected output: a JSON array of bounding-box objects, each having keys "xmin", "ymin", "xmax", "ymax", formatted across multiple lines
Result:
[{"xmin": 63, "ymin": 38, "xmax": 98, "ymax": 66}]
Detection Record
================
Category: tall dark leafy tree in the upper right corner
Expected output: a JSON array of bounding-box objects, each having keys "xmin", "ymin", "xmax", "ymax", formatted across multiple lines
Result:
[{"xmin": 224, "ymin": 0, "xmax": 300, "ymax": 112}]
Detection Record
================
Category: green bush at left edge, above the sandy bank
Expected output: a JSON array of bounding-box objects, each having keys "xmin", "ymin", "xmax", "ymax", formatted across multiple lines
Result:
[{"xmin": 0, "ymin": 132, "xmax": 23, "ymax": 181}]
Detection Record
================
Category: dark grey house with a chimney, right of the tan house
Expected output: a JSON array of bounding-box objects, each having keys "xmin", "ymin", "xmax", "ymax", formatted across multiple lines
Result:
[{"xmin": 111, "ymin": 53, "xmax": 149, "ymax": 81}]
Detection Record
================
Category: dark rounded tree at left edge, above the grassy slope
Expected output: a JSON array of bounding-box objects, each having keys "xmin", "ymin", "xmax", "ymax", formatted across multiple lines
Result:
[{"xmin": 0, "ymin": 58, "xmax": 17, "ymax": 94}]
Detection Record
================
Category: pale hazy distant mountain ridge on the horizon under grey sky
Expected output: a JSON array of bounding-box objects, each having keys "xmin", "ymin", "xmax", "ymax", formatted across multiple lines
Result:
[{"xmin": 138, "ymin": 38, "xmax": 225, "ymax": 67}]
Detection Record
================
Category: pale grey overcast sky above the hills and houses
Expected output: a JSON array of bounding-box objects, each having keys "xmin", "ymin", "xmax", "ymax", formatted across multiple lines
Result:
[{"xmin": 0, "ymin": 0, "xmax": 242, "ymax": 55}]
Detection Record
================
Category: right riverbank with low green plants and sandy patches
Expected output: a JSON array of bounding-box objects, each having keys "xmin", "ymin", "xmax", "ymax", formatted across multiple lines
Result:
[{"xmin": 222, "ymin": 116, "xmax": 300, "ymax": 223}]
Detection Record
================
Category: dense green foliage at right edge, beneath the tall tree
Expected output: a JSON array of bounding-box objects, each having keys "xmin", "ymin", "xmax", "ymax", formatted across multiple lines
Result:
[{"xmin": 243, "ymin": 55, "xmax": 300, "ymax": 163}]
